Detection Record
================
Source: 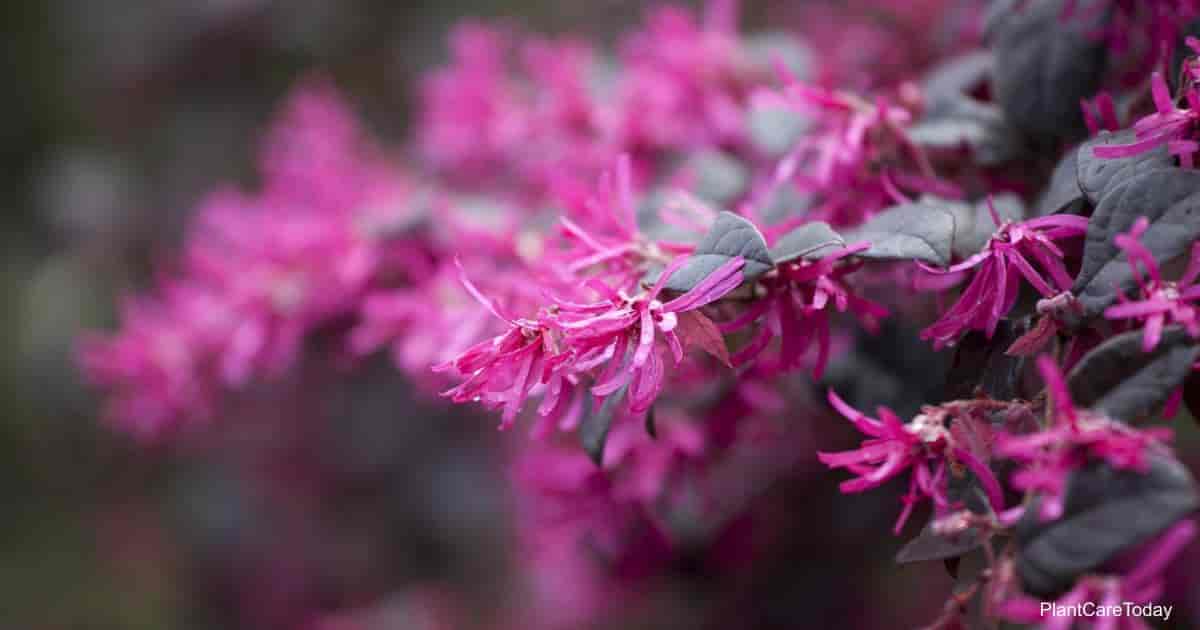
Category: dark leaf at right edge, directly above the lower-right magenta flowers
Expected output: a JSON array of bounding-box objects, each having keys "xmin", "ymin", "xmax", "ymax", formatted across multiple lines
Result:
[{"xmin": 1067, "ymin": 326, "xmax": 1200, "ymax": 421}]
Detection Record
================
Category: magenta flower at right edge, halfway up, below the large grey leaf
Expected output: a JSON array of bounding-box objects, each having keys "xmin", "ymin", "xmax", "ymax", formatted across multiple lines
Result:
[{"xmin": 1104, "ymin": 217, "xmax": 1200, "ymax": 352}]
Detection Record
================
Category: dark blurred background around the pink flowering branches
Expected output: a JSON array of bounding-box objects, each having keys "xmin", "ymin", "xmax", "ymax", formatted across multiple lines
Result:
[{"xmin": 0, "ymin": 0, "xmax": 1194, "ymax": 629}]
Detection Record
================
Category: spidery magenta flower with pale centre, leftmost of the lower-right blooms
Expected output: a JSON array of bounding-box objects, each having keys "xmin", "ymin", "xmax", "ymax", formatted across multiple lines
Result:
[{"xmin": 817, "ymin": 390, "xmax": 1004, "ymax": 534}]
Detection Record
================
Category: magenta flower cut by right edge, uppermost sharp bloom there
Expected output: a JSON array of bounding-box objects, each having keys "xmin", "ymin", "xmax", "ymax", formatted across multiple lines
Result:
[{"xmin": 1092, "ymin": 72, "xmax": 1200, "ymax": 168}]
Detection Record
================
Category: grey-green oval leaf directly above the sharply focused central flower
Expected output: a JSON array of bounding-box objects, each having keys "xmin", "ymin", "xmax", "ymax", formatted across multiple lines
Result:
[{"xmin": 666, "ymin": 212, "xmax": 774, "ymax": 293}]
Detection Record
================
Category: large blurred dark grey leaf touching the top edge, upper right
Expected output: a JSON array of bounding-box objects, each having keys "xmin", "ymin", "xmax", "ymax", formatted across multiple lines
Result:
[{"xmin": 988, "ymin": 0, "xmax": 1109, "ymax": 140}]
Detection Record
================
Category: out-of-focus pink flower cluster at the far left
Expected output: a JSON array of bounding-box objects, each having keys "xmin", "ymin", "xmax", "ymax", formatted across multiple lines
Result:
[{"xmin": 82, "ymin": 82, "xmax": 418, "ymax": 439}]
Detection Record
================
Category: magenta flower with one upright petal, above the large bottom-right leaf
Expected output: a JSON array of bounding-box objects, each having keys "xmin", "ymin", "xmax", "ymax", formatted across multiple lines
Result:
[{"xmin": 995, "ymin": 355, "xmax": 1172, "ymax": 520}]
